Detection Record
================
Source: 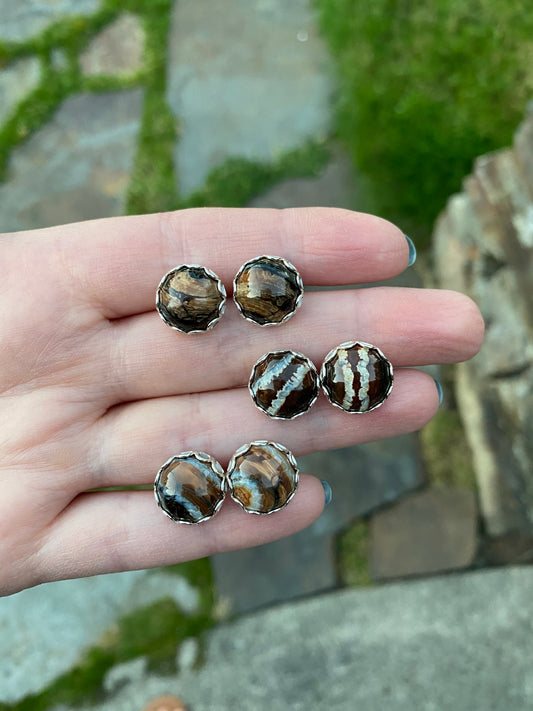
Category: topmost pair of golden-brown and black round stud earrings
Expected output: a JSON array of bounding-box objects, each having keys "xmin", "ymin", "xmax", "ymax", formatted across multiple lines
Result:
[{"xmin": 156, "ymin": 255, "xmax": 303, "ymax": 333}]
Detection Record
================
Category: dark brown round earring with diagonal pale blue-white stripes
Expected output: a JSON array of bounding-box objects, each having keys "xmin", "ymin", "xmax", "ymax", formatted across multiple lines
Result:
[{"xmin": 248, "ymin": 351, "xmax": 319, "ymax": 420}]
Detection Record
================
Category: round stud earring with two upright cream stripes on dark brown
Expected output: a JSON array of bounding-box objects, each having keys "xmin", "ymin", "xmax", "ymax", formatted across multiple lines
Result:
[{"xmin": 320, "ymin": 341, "xmax": 393, "ymax": 413}]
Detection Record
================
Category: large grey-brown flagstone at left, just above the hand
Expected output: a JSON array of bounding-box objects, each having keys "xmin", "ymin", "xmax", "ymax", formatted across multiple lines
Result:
[{"xmin": 0, "ymin": 89, "xmax": 143, "ymax": 232}]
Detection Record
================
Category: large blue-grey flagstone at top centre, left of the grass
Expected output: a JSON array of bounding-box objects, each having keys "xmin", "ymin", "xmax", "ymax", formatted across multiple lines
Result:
[{"xmin": 167, "ymin": 0, "xmax": 334, "ymax": 195}]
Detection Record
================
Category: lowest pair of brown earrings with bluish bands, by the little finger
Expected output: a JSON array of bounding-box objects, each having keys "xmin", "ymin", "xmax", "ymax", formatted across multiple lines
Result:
[{"xmin": 154, "ymin": 440, "xmax": 299, "ymax": 524}]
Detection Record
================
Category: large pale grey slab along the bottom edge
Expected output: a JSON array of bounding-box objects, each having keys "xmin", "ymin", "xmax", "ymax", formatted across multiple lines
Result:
[{"xmin": 55, "ymin": 568, "xmax": 533, "ymax": 711}]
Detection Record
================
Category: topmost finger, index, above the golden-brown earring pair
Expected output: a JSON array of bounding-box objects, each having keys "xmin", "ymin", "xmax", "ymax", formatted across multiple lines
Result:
[{"xmin": 37, "ymin": 208, "xmax": 409, "ymax": 318}]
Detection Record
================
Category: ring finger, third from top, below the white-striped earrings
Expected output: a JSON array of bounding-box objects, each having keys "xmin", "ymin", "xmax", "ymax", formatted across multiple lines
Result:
[{"xmin": 86, "ymin": 370, "xmax": 439, "ymax": 491}]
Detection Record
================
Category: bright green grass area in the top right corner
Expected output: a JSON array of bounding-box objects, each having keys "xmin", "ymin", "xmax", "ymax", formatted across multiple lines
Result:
[{"xmin": 315, "ymin": 0, "xmax": 533, "ymax": 244}]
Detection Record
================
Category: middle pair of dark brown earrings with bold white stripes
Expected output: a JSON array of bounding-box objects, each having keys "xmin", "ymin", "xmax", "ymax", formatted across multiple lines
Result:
[{"xmin": 248, "ymin": 341, "xmax": 393, "ymax": 420}]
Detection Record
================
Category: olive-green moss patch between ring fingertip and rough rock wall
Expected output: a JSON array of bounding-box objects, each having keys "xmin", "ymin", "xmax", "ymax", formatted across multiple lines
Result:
[{"xmin": 420, "ymin": 410, "xmax": 476, "ymax": 490}]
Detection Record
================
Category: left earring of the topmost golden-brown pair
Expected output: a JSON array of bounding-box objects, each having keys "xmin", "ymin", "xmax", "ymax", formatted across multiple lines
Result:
[{"xmin": 156, "ymin": 264, "xmax": 226, "ymax": 333}]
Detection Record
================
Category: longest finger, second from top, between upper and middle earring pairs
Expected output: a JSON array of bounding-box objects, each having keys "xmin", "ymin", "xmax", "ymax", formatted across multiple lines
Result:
[{"xmin": 101, "ymin": 287, "xmax": 483, "ymax": 403}]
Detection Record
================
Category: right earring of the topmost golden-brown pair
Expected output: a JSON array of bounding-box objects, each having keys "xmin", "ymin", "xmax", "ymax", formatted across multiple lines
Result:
[{"xmin": 233, "ymin": 255, "xmax": 303, "ymax": 326}]
